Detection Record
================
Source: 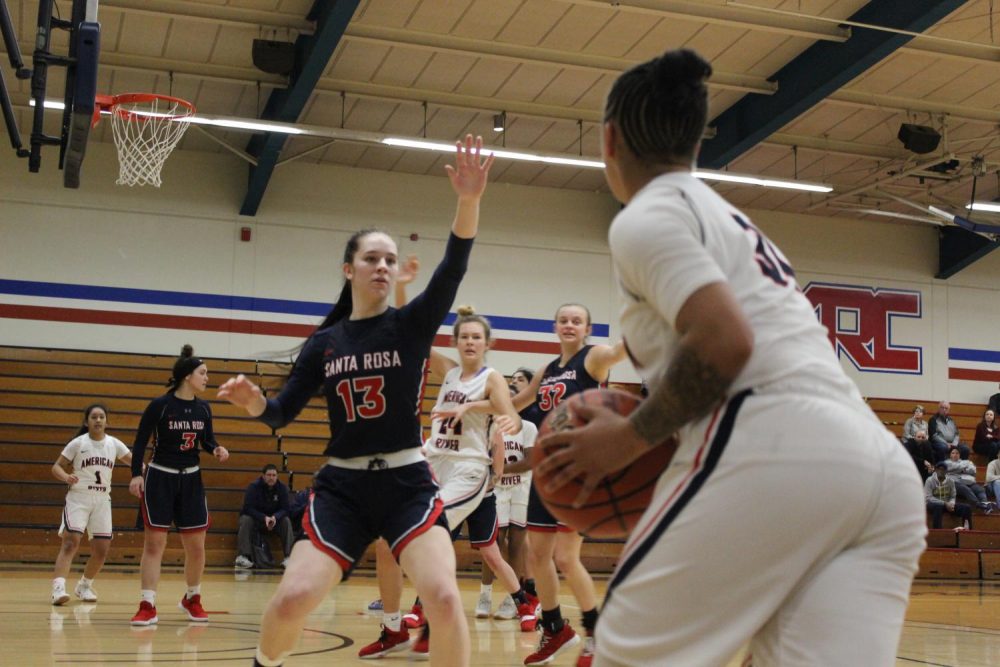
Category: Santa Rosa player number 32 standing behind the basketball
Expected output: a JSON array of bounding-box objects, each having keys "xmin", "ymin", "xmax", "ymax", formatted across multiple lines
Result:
[{"xmin": 514, "ymin": 303, "xmax": 625, "ymax": 667}]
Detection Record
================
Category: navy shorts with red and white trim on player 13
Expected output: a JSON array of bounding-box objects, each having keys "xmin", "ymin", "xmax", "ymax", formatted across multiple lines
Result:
[{"xmin": 302, "ymin": 461, "xmax": 448, "ymax": 578}]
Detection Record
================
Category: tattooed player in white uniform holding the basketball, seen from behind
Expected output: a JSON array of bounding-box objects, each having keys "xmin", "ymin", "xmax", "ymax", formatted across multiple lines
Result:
[{"xmin": 536, "ymin": 50, "xmax": 926, "ymax": 667}]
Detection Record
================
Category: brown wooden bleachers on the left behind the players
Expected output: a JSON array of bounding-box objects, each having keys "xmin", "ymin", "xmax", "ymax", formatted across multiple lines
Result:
[{"xmin": 0, "ymin": 346, "xmax": 622, "ymax": 572}]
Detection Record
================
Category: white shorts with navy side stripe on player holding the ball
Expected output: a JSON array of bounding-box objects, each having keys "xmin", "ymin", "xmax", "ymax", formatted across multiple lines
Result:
[{"xmin": 595, "ymin": 389, "xmax": 927, "ymax": 667}]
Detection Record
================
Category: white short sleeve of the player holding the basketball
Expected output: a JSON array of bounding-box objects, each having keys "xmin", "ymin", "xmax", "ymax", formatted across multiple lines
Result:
[{"xmin": 609, "ymin": 197, "xmax": 726, "ymax": 327}]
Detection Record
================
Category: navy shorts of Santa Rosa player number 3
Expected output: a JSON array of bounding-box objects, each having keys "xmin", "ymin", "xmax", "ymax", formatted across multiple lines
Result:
[{"xmin": 140, "ymin": 463, "xmax": 211, "ymax": 532}]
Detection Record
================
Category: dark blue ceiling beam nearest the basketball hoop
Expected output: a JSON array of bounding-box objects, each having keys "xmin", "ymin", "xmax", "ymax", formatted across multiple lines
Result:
[{"xmin": 240, "ymin": 0, "xmax": 360, "ymax": 215}]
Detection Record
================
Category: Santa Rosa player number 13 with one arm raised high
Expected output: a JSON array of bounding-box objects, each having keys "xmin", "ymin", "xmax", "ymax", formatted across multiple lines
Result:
[{"xmin": 219, "ymin": 135, "xmax": 493, "ymax": 667}]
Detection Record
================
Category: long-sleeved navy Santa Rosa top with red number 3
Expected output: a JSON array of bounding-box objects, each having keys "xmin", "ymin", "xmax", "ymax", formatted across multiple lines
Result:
[{"xmin": 132, "ymin": 392, "xmax": 218, "ymax": 477}]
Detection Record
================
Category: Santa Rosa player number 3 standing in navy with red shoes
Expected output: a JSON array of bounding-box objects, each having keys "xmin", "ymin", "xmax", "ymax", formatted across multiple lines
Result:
[{"xmin": 129, "ymin": 345, "xmax": 229, "ymax": 625}]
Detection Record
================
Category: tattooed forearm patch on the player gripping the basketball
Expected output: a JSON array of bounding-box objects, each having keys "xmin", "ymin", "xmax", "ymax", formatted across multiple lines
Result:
[{"xmin": 631, "ymin": 345, "xmax": 732, "ymax": 446}]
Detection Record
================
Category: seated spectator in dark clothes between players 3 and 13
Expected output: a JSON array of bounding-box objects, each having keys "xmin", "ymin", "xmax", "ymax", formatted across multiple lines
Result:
[{"xmin": 236, "ymin": 463, "xmax": 295, "ymax": 570}]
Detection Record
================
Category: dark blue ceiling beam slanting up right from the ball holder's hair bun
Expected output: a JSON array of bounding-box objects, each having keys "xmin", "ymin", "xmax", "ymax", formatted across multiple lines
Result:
[{"xmin": 699, "ymin": 0, "xmax": 966, "ymax": 169}]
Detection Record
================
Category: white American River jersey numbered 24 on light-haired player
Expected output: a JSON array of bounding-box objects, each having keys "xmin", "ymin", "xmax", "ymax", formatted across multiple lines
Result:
[{"xmin": 425, "ymin": 366, "xmax": 493, "ymax": 465}]
